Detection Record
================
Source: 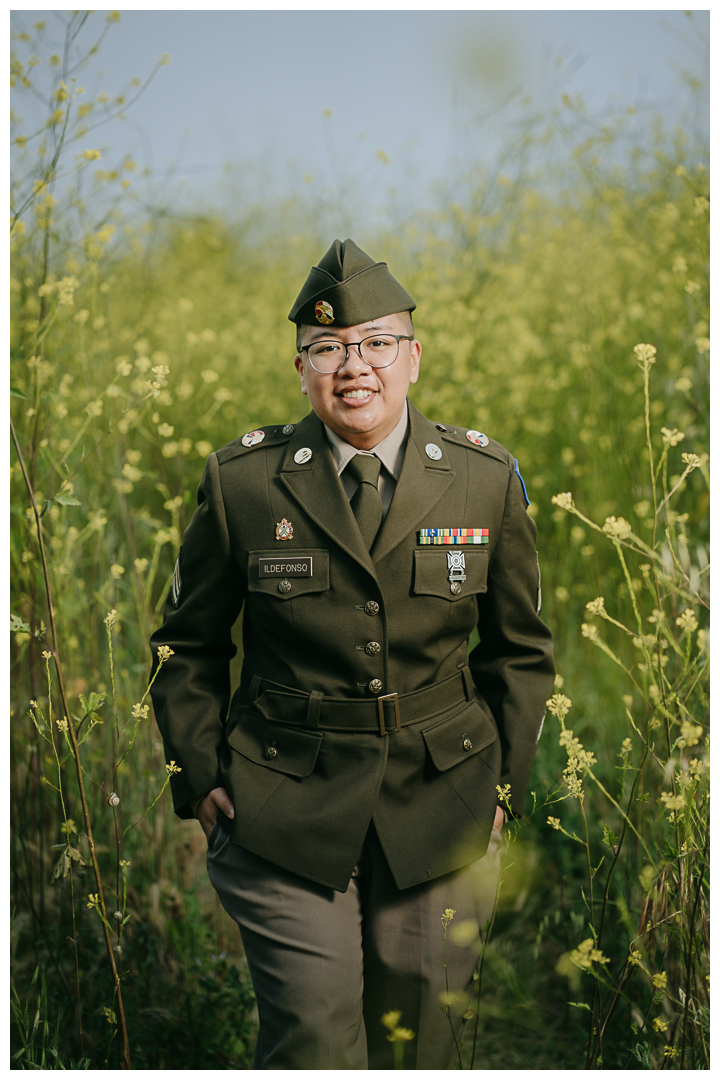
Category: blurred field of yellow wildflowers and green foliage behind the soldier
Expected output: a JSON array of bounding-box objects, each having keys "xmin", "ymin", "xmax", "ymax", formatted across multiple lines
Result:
[{"xmin": 11, "ymin": 15, "xmax": 709, "ymax": 1068}]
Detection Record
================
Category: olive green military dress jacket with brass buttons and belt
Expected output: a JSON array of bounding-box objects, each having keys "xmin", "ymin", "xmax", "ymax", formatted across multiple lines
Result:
[{"xmin": 151, "ymin": 404, "xmax": 554, "ymax": 891}]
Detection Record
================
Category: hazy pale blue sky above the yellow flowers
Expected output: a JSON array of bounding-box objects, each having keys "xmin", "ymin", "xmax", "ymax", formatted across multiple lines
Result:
[{"xmin": 13, "ymin": 11, "xmax": 709, "ymax": 230}]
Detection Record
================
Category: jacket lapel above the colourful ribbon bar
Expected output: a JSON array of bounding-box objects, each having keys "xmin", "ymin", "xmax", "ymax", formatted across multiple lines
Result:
[{"xmin": 371, "ymin": 401, "xmax": 454, "ymax": 564}]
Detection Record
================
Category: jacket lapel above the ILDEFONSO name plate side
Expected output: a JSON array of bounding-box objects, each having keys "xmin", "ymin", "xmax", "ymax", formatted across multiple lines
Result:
[{"xmin": 281, "ymin": 413, "xmax": 376, "ymax": 578}]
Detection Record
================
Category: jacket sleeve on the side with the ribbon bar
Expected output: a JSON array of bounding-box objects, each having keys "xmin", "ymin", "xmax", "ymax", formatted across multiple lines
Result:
[{"xmin": 468, "ymin": 470, "xmax": 555, "ymax": 816}]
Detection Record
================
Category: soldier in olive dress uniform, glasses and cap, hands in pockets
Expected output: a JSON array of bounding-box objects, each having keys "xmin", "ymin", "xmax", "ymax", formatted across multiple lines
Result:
[{"xmin": 151, "ymin": 240, "xmax": 553, "ymax": 1069}]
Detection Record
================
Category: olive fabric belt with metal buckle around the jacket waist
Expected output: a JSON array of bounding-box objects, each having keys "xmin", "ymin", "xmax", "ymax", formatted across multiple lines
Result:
[{"xmin": 240, "ymin": 666, "xmax": 475, "ymax": 735}]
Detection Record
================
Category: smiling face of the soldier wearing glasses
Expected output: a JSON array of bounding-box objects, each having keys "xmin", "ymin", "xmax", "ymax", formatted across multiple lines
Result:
[{"xmin": 295, "ymin": 313, "xmax": 422, "ymax": 450}]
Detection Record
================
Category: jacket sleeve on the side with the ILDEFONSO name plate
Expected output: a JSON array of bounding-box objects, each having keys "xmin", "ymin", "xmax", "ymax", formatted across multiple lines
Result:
[{"xmin": 150, "ymin": 454, "xmax": 247, "ymax": 818}]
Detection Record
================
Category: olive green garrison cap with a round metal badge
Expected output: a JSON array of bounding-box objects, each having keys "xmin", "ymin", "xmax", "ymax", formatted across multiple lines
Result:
[{"xmin": 287, "ymin": 240, "xmax": 417, "ymax": 326}]
